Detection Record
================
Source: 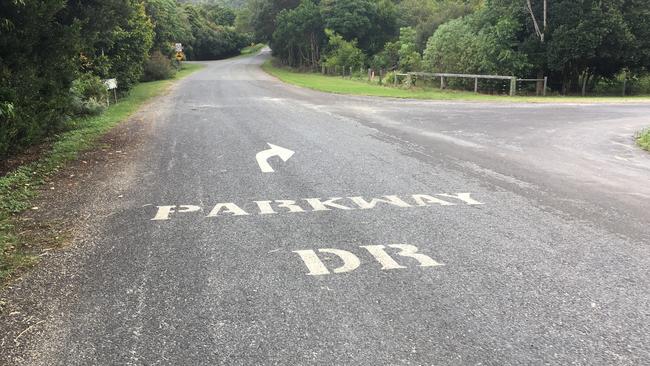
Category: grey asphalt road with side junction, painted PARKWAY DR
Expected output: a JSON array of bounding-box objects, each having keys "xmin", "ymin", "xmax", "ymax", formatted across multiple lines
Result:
[{"xmin": 3, "ymin": 50, "xmax": 650, "ymax": 365}]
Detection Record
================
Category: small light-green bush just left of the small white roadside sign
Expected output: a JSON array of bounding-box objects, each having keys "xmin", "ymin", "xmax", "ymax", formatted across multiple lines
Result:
[{"xmin": 70, "ymin": 73, "xmax": 108, "ymax": 116}]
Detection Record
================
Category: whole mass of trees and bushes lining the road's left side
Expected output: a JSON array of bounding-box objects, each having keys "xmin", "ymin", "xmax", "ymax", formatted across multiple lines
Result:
[{"xmin": 0, "ymin": 0, "xmax": 250, "ymax": 159}]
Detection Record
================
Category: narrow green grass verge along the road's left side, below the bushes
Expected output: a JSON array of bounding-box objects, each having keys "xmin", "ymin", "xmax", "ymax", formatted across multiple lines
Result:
[{"xmin": 0, "ymin": 64, "xmax": 203, "ymax": 284}]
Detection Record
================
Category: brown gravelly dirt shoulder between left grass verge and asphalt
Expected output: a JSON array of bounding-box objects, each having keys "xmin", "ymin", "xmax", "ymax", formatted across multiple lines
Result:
[{"xmin": 0, "ymin": 102, "xmax": 157, "ymax": 365}]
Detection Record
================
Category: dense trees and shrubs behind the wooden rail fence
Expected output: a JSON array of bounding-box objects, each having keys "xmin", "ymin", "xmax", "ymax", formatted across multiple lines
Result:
[{"xmin": 249, "ymin": 0, "xmax": 650, "ymax": 94}]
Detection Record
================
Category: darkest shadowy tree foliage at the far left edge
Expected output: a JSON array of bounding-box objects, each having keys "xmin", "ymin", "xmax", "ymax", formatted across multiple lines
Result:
[{"xmin": 0, "ymin": 0, "xmax": 80, "ymax": 158}]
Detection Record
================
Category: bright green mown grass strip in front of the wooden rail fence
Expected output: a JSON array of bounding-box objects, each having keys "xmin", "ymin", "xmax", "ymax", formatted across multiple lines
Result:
[{"xmin": 262, "ymin": 60, "xmax": 650, "ymax": 103}]
